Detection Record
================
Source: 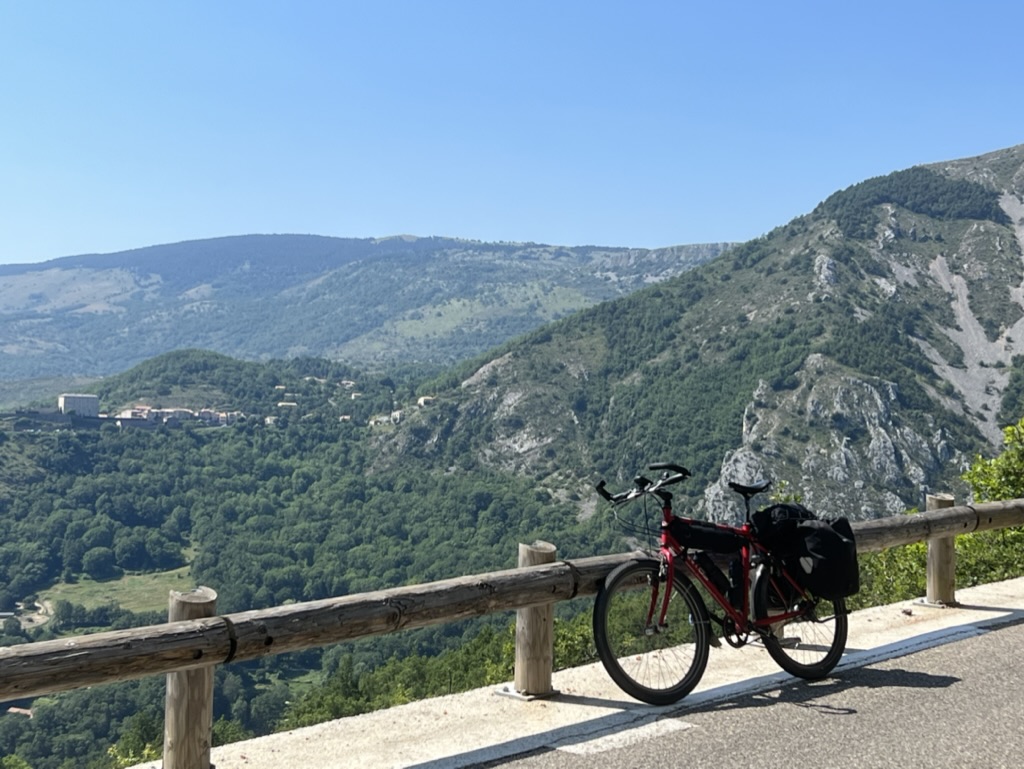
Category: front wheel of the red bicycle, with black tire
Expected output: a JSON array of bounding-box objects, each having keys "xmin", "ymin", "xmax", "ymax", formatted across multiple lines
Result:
[{"xmin": 594, "ymin": 559, "xmax": 711, "ymax": 706}]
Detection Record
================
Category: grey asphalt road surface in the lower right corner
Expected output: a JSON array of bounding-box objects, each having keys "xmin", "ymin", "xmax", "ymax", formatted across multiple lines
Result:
[{"xmin": 477, "ymin": 620, "xmax": 1024, "ymax": 769}]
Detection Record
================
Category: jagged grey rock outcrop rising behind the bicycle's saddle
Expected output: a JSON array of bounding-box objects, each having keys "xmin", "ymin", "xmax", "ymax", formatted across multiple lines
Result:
[{"xmin": 698, "ymin": 354, "xmax": 969, "ymax": 522}]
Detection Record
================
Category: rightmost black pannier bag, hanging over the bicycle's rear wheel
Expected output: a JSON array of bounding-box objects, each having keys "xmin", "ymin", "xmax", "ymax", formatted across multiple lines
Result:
[{"xmin": 783, "ymin": 518, "xmax": 860, "ymax": 600}]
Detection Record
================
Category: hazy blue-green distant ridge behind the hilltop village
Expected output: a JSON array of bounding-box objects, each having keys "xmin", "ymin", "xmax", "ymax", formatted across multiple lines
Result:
[{"xmin": 0, "ymin": 236, "xmax": 728, "ymax": 390}]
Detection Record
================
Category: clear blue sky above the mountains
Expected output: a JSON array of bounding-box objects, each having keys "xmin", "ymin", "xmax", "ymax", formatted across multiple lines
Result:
[{"xmin": 0, "ymin": 0, "xmax": 1024, "ymax": 264}]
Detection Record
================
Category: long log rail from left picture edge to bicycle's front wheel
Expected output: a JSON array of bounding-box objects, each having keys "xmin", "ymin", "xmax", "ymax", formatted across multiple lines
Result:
[{"xmin": 0, "ymin": 553, "xmax": 631, "ymax": 701}]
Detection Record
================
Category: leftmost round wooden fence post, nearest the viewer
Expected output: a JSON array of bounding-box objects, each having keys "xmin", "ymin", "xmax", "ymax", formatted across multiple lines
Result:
[{"xmin": 163, "ymin": 587, "xmax": 217, "ymax": 769}]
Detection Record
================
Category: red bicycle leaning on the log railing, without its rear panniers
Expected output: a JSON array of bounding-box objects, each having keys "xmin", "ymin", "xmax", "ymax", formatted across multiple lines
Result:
[{"xmin": 594, "ymin": 463, "xmax": 847, "ymax": 704}]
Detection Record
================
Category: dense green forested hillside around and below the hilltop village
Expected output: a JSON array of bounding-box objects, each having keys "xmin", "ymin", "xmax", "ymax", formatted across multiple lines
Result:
[{"xmin": 0, "ymin": 351, "xmax": 611, "ymax": 611}]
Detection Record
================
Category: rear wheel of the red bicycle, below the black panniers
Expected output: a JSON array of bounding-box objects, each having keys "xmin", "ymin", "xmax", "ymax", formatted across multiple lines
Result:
[{"xmin": 754, "ymin": 567, "xmax": 848, "ymax": 681}]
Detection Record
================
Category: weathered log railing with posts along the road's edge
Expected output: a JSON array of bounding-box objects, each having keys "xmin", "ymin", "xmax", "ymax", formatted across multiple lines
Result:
[{"xmin": 0, "ymin": 497, "xmax": 1024, "ymax": 769}]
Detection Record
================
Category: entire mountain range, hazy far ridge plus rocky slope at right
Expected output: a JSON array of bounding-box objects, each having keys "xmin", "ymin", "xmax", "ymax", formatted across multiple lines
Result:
[{"xmin": 0, "ymin": 145, "xmax": 1024, "ymax": 519}]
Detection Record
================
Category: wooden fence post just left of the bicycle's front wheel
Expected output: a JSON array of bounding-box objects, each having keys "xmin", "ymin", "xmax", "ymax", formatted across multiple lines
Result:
[{"xmin": 514, "ymin": 541, "xmax": 556, "ymax": 696}]
